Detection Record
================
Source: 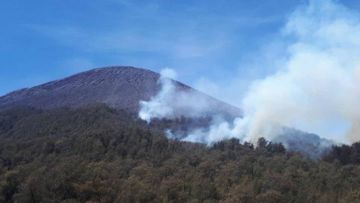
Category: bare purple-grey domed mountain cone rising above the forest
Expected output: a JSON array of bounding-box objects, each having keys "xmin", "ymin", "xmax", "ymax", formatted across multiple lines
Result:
[{"xmin": 0, "ymin": 66, "xmax": 241, "ymax": 116}]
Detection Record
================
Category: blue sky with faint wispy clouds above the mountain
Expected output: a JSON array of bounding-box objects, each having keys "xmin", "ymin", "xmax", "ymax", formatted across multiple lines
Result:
[{"xmin": 0, "ymin": 0, "xmax": 360, "ymax": 95}]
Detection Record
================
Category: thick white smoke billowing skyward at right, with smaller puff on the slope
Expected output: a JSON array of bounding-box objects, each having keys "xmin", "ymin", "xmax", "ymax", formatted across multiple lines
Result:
[{"xmin": 139, "ymin": 0, "xmax": 360, "ymax": 144}]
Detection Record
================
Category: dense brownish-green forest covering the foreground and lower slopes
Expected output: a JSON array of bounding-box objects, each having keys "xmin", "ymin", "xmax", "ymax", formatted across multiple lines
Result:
[{"xmin": 0, "ymin": 105, "xmax": 360, "ymax": 203}]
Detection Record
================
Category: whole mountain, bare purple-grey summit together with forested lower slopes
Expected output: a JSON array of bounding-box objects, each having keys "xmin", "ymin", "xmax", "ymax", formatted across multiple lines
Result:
[{"xmin": 0, "ymin": 67, "xmax": 360, "ymax": 203}]
